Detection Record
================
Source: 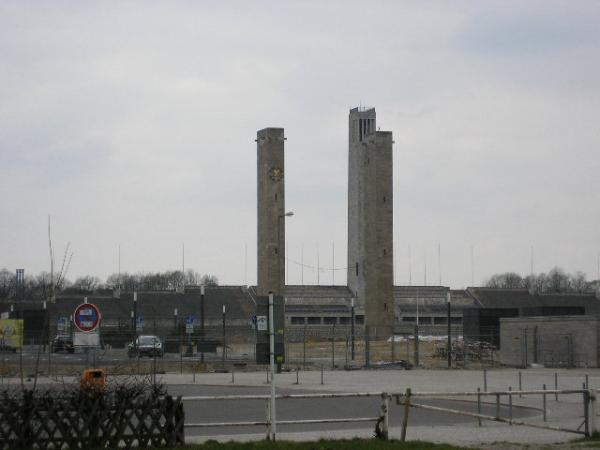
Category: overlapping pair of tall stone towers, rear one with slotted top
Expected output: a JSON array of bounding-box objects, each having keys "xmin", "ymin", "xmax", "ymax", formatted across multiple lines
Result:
[{"xmin": 348, "ymin": 108, "xmax": 394, "ymax": 337}]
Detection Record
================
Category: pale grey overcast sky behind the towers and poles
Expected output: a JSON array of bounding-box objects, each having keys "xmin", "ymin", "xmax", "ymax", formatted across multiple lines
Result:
[{"xmin": 0, "ymin": 0, "xmax": 600, "ymax": 288}]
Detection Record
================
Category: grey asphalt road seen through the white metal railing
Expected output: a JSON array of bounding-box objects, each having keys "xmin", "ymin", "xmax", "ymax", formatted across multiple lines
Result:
[{"xmin": 168, "ymin": 385, "xmax": 539, "ymax": 436}]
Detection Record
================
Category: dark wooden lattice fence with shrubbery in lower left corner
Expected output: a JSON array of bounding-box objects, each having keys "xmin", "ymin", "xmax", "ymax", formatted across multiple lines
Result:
[{"xmin": 0, "ymin": 394, "xmax": 185, "ymax": 450}]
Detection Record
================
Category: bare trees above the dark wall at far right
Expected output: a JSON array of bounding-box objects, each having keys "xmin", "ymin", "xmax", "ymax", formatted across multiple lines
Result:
[{"xmin": 485, "ymin": 267, "xmax": 600, "ymax": 294}]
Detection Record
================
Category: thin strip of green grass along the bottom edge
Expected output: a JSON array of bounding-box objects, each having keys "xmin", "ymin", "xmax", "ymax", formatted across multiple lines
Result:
[{"xmin": 180, "ymin": 439, "xmax": 476, "ymax": 450}]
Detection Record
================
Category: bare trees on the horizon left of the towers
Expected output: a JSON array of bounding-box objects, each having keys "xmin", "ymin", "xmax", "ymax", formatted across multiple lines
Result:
[{"xmin": 0, "ymin": 268, "xmax": 219, "ymax": 299}]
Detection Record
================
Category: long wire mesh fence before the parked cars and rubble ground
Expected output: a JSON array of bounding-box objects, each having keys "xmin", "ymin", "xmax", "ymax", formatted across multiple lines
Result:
[{"xmin": 0, "ymin": 324, "xmax": 506, "ymax": 380}]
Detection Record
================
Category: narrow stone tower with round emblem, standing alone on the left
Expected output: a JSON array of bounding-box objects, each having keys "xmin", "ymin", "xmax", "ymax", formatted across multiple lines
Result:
[{"xmin": 256, "ymin": 128, "xmax": 285, "ymax": 295}]
